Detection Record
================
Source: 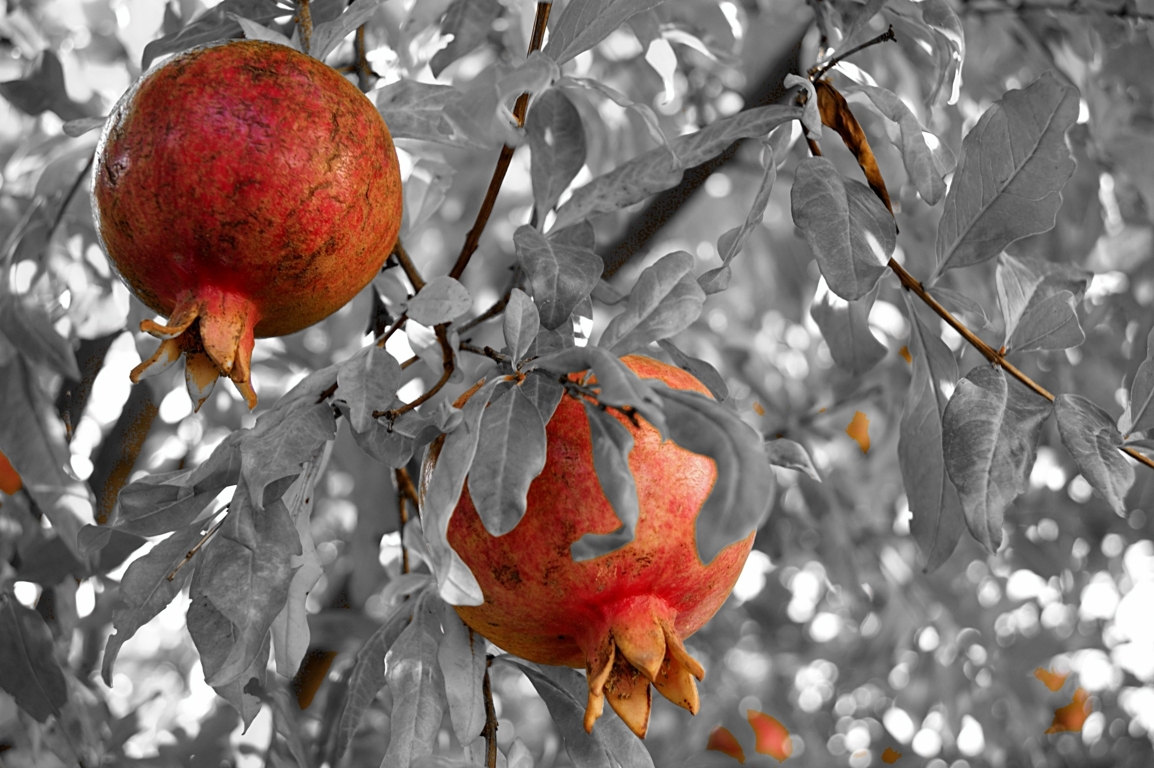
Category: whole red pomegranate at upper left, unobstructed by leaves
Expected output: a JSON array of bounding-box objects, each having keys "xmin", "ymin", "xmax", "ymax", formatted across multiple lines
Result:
[{"xmin": 92, "ymin": 40, "xmax": 402, "ymax": 408}]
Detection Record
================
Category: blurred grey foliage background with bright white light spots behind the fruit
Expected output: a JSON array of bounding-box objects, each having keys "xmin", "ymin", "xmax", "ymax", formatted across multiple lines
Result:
[{"xmin": 0, "ymin": 0, "xmax": 1154, "ymax": 768}]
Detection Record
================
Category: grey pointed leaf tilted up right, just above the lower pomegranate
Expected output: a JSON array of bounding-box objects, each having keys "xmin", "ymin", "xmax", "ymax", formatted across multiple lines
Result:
[{"xmin": 599, "ymin": 250, "xmax": 705, "ymax": 355}]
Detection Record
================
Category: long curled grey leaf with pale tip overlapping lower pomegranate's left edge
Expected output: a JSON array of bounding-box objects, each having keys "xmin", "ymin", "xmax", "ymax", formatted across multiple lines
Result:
[{"xmin": 421, "ymin": 377, "xmax": 503, "ymax": 605}]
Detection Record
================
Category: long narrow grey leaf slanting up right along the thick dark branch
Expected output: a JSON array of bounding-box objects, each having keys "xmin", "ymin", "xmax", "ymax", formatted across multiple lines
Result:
[{"xmin": 553, "ymin": 105, "xmax": 801, "ymax": 229}]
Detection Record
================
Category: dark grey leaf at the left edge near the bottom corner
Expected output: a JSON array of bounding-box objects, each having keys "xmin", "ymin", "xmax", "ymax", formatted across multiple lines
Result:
[{"xmin": 0, "ymin": 594, "xmax": 68, "ymax": 723}]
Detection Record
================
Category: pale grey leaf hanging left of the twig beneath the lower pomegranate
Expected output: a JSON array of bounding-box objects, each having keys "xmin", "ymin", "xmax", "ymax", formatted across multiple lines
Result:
[{"xmin": 437, "ymin": 603, "xmax": 488, "ymax": 744}]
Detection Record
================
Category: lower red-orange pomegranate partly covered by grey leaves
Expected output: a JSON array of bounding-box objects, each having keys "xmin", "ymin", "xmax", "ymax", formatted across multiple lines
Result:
[{"xmin": 433, "ymin": 356, "xmax": 754, "ymax": 737}]
